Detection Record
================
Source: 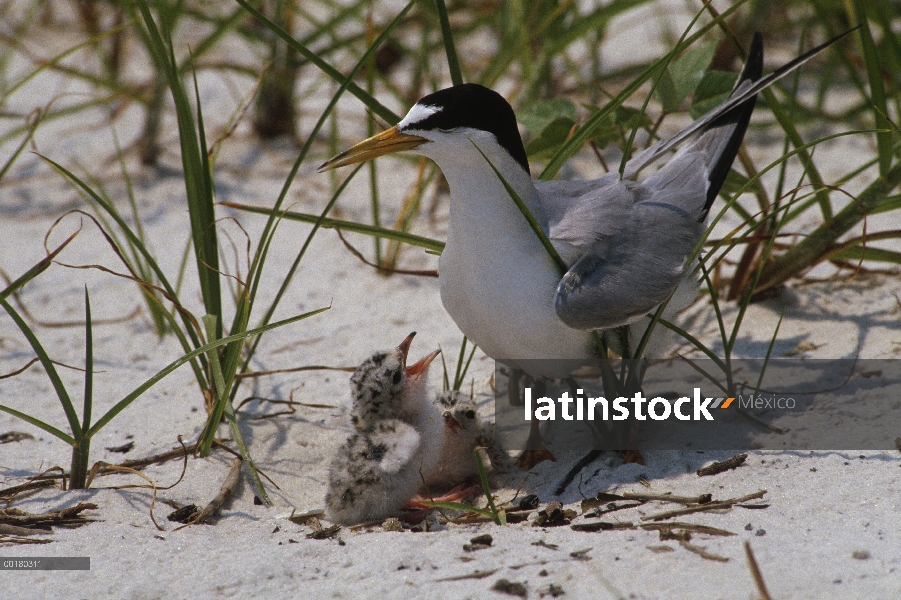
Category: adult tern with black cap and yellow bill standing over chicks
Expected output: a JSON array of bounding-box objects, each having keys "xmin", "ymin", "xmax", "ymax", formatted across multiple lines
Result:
[{"xmin": 319, "ymin": 30, "xmax": 853, "ymax": 377}]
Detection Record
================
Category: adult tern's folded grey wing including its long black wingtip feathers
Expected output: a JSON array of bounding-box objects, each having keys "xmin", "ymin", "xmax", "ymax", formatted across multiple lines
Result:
[{"xmin": 539, "ymin": 35, "xmax": 763, "ymax": 330}]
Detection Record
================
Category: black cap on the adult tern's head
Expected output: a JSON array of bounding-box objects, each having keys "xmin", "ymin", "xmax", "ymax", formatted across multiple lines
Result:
[{"xmin": 400, "ymin": 83, "xmax": 530, "ymax": 173}]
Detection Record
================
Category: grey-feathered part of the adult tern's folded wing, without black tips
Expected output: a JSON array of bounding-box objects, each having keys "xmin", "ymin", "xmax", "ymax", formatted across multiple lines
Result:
[{"xmin": 549, "ymin": 176, "xmax": 706, "ymax": 330}]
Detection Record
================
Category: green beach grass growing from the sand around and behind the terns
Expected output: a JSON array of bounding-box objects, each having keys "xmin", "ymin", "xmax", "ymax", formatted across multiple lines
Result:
[{"xmin": 0, "ymin": 0, "xmax": 901, "ymax": 496}]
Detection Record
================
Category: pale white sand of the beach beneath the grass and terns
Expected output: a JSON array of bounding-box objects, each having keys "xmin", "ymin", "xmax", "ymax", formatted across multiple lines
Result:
[{"xmin": 0, "ymin": 5, "xmax": 901, "ymax": 598}]
